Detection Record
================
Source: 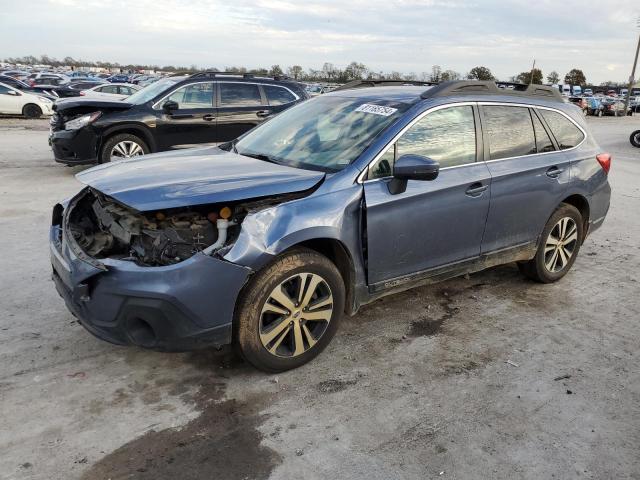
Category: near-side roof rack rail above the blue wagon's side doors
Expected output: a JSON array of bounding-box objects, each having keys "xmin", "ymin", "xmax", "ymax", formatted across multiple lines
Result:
[{"xmin": 420, "ymin": 80, "xmax": 563, "ymax": 102}]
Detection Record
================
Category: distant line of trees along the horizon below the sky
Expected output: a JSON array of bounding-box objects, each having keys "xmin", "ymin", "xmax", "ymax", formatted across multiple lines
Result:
[{"xmin": 4, "ymin": 55, "xmax": 617, "ymax": 86}]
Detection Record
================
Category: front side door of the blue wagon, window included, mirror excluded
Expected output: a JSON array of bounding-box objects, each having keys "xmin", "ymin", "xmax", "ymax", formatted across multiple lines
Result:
[{"xmin": 364, "ymin": 104, "xmax": 491, "ymax": 290}]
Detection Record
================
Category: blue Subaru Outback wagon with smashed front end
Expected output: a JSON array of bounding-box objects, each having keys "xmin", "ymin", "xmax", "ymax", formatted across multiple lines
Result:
[{"xmin": 50, "ymin": 81, "xmax": 611, "ymax": 372}]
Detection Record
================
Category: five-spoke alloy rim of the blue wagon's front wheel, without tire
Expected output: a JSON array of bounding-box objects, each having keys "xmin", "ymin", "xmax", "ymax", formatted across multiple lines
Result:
[{"xmin": 259, "ymin": 273, "xmax": 333, "ymax": 358}]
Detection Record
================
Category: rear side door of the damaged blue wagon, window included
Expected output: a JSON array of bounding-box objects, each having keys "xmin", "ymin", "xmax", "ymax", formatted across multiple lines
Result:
[{"xmin": 480, "ymin": 104, "xmax": 570, "ymax": 254}]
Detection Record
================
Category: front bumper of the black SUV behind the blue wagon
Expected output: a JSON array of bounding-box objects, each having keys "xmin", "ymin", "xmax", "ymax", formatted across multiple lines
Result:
[{"xmin": 49, "ymin": 127, "xmax": 98, "ymax": 165}]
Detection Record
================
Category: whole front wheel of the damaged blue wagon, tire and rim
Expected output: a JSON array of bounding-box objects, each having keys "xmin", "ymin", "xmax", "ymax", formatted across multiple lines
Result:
[{"xmin": 235, "ymin": 249, "xmax": 345, "ymax": 373}]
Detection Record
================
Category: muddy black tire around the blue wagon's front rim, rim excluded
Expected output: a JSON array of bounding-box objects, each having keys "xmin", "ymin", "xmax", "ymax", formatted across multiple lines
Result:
[{"xmin": 234, "ymin": 249, "xmax": 345, "ymax": 373}]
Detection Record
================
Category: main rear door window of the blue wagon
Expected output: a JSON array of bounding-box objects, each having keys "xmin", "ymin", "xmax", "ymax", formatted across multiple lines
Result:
[{"xmin": 483, "ymin": 106, "xmax": 537, "ymax": 160}]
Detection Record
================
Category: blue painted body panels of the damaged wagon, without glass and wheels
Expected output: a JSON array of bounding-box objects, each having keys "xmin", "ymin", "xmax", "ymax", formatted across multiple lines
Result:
[{"xmin": 52, "ymin": 87, "xmax": 610, "ymax": 343}]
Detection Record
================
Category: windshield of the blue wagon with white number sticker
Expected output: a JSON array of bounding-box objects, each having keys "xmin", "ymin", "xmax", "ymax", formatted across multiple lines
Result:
[{"xmin": 236, "ymin": 96, "xmax": 409, "ymax": 172}]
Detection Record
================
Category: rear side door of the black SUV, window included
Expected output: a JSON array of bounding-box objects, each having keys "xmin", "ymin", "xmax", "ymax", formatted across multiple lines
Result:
[{"xmin": 216, "ymin": 82, "xmax": 269, "ymax": 142}]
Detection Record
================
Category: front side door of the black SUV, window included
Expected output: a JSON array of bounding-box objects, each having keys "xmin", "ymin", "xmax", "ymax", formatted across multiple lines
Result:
[{"xmin": 156, "ymin": 82, "xmax": 217, "ymax": 150}]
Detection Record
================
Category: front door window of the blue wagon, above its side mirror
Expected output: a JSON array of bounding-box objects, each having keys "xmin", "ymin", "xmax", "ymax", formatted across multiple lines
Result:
[{"xmin": 398, "ymin": 106, "xmax": 476, "ymax": 168}]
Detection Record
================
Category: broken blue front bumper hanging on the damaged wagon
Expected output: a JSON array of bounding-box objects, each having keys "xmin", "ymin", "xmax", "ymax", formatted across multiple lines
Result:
[{"xmin": 50, "ymin": 225, "xmax": 251, "ymax": 351}]
